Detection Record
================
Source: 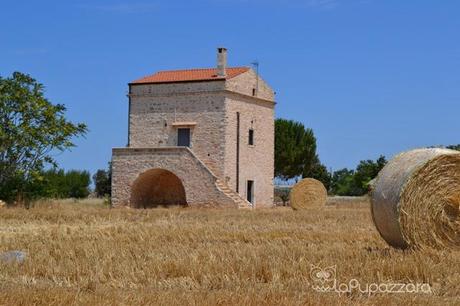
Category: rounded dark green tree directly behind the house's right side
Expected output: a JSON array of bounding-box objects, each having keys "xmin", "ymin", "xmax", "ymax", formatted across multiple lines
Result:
[{"xmin": 275, "ymin": 119, "xmax": 317, "ymax": 179}]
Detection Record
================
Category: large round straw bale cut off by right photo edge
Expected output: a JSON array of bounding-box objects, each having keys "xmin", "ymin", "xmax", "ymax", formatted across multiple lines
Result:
[{"xmin": 371, "ymin": 149, "xmax": 460, "ymax": 249}]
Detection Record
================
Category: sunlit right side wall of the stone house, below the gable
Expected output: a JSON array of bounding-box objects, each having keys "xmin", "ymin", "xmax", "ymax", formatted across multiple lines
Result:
[{"xmin": 224, "ymin": 96, "xmax": 274, "ymax": 207}]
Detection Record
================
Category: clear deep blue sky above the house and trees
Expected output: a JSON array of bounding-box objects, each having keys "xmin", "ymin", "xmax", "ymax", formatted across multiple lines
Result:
[{"xmin": 0, "ymin": 0, "xmax": 460, "ymax": 176}]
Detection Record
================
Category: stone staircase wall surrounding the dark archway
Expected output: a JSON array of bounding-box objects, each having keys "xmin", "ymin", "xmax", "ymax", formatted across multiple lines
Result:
[{"xmin": 112, "ymin": 147, "xmax": 236, "ymax": 207}]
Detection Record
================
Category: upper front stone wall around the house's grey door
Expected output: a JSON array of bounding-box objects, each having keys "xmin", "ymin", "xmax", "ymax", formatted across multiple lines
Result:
[{"xmin": 130, "ymin": 89, "xmax": 225, "ymax": 176}]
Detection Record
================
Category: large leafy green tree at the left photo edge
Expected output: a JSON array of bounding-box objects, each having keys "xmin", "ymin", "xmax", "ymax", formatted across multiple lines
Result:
[{"xmin": 0, "ymin": 72, "xmax": 87, "ymax": 201}]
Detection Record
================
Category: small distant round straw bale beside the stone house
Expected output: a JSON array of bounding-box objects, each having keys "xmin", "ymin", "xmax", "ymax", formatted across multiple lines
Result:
[{"xmin": 290, "ymin": 178, "xmax": 327, "ymax": 209}]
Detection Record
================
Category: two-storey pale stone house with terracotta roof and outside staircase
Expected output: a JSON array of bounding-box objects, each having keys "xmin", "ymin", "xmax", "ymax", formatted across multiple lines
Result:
[{"xmin": 112, "ymin": 48, "xmax": 275, "ymax": 208}]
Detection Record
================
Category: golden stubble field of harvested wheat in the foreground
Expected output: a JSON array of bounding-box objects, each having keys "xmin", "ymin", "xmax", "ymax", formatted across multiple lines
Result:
[{"xmin": 0, "ymin": 198, "xmax": 460, "ymax": 305}]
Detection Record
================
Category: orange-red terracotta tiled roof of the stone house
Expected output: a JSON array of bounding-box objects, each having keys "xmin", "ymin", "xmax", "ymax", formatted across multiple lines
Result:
[{"xmin": 130, "ymin": 67, "xmax": 249, "ymax": 84}]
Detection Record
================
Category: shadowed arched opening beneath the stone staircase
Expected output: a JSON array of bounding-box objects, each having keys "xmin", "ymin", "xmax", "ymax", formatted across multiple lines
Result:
[{"xmin": 130, "ymin": 169, "xmax": 187, "ymax": 208}]
